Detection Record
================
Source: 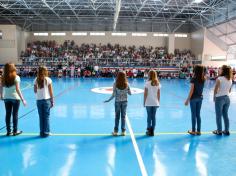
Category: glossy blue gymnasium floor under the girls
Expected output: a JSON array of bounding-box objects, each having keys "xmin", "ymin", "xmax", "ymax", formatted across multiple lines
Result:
[{"xmin": 0, "ymin": 79, "xmax": 236, "ymax": 176}]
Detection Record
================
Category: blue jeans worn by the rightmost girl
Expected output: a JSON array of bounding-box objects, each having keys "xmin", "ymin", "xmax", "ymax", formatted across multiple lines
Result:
[{"xmin": 215, "ymin": 96, "xmax": 230, "ymax": 131}]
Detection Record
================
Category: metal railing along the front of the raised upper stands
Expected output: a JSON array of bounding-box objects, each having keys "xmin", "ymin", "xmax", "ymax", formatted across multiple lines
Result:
[{"xmin": 20, "ymin": 57, "xmax": 201, "ymax": 67}]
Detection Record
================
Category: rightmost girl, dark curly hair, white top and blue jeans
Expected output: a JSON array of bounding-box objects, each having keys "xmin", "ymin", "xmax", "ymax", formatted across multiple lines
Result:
[{"xmin": 213, "ymin": 65, "xmax": 233, "ymax": 135}]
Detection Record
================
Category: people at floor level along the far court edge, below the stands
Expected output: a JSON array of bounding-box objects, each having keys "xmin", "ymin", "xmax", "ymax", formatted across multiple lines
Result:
[{"xmin": 0, "ymin": 64, "xmax": 236, "ymax": 83}]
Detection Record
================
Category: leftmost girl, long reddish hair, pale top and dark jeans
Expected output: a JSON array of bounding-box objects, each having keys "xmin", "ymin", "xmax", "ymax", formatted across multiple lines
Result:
[{"xmin": 0, "ymin": 63, "xmax": 26, "ymax": 136}]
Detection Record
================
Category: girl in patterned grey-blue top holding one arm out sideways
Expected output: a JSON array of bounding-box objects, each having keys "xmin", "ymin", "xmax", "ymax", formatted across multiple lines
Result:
[{"xmin": 105, "ymin": 72, "xmax": 131, "ymax": 136}]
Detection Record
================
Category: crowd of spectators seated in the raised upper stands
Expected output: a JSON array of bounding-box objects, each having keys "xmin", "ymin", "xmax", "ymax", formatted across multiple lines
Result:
[{"xmin": 21, "ymin": 40, "xmax": 196, "ymax": 67}]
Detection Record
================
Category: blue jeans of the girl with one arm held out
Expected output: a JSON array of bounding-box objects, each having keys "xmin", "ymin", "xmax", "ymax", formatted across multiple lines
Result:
[{"xmin": 114, "ymin": 101, "xmax": 127, "ymax": 132}]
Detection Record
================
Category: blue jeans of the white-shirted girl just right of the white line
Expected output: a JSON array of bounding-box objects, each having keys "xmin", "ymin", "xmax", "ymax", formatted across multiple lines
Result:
[{"xmin": 146, "ymin": 106, "xmax": 157, "ymax": 130}]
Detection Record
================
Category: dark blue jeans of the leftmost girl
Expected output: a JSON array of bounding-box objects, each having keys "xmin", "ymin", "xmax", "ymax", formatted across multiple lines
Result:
[{"xmin": 4, "ymin": 99, "xmax": 20, "ymax": 133}]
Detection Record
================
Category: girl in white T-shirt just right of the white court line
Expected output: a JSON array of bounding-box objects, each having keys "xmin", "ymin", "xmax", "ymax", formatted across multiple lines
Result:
[{"xmin": 144, "ymin": 70, "xmax": 161, "ymax": 136}]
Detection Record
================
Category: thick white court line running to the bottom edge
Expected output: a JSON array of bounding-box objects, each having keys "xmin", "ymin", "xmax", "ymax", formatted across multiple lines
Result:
[{"xmin": 126, "ymin": 115, "xmax": 148, "ymax": 176}]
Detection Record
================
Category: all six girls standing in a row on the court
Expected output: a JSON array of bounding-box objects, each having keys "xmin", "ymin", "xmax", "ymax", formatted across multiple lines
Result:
[{"xmin": 0, "ymin": 63, "xmax": 232, "ymax": 137}]
